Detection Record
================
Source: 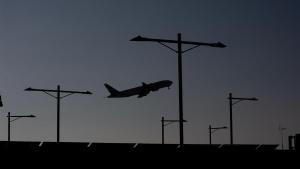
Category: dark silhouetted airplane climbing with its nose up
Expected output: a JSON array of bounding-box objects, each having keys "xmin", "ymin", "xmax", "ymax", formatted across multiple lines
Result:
[{"xmin": 104, "ymin": 80, "xmax": 173, "ymax": 98}]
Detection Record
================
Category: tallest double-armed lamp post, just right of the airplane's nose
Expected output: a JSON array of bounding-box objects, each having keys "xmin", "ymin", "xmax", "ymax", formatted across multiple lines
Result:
[{"xmin": 131, "ymin": 33, "xmax": 226, "ymax": 147}]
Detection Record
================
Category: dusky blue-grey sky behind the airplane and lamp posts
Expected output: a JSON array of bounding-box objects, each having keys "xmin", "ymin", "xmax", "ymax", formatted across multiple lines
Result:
[{"xmin": 0, "ymin": 0, "xmax": 300, "ymax": 147}]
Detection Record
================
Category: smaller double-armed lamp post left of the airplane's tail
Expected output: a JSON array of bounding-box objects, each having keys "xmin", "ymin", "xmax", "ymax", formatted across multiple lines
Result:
[{"xmin": 25, "ymin": 85, "xmax": 92, "ymax": 143}]
